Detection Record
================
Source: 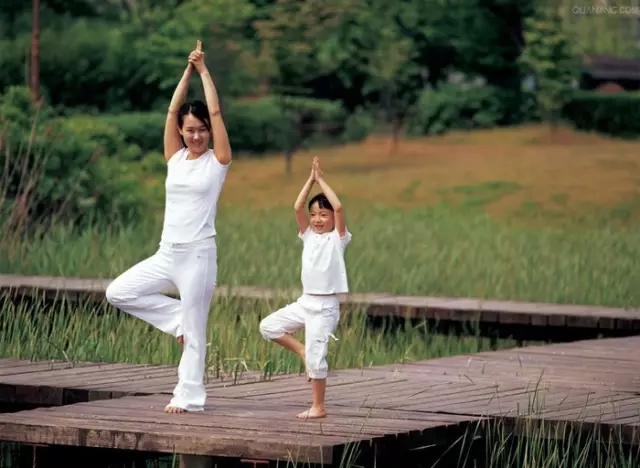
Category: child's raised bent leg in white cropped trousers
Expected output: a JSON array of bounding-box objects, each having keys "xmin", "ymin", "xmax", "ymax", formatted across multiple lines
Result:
[{"xmin": 260, "ymin": 302, "xmax": 305, "ymax": 361}]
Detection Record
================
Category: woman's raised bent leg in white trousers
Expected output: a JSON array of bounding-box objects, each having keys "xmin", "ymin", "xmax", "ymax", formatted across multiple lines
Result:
[{"xmin": 106, "ymin": 253, "xmax": 182, "ymax": 337}]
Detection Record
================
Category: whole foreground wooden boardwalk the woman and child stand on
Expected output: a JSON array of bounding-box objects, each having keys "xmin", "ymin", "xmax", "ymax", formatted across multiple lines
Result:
[{"xmin": 0, "ymin": 337, "xmax": 640, "ymax": 465}]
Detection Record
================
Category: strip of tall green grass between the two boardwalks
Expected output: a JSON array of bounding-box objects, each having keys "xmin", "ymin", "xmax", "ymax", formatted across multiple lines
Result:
[{"xmin": 0, "ymin": 299, "xmax": 516, "ymax": 377}]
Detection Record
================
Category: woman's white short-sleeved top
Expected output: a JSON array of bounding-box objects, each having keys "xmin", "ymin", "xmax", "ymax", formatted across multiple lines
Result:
[{"xmin": 161, "ymin": 148, "xmax": 229, "ymax": 243}]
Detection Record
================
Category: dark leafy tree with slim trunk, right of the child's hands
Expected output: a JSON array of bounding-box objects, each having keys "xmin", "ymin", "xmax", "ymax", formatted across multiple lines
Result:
[{"xmin": 258, "ymin": 0, "xmax": 440, "ymax": 155}]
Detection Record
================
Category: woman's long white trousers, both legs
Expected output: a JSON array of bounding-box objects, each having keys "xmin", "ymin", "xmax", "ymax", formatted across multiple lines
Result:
[{"xmin": 106, "ymin": 237, "xmax": 218, "ymax": 411}]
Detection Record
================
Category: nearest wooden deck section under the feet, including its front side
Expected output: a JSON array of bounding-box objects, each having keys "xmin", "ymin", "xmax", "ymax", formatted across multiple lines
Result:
[{"xmin": 0, "ymin": 395, "xmax": 475, "ymax": 462}]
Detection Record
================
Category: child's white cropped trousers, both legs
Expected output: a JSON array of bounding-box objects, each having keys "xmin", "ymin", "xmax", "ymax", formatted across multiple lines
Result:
[{"xmin": 260, "ymin": 294, "xmax": 340, "ymax": 379}]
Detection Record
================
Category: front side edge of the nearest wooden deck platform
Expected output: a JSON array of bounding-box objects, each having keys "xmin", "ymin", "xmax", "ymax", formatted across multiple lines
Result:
[{"xmin": 0, "ymin": 398, "xmax": 487, "ymax": 468}]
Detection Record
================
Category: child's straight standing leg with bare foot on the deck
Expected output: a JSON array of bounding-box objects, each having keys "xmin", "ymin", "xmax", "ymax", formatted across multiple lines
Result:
[{"xmin": 298, "ymin": 308, "xmax": 340, "ymax": 419}]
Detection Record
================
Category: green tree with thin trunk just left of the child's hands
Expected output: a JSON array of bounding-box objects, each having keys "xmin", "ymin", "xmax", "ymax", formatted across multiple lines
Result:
[{"xmin": 254, "ymin": 0, "xmax": 358, "ymax": 175}]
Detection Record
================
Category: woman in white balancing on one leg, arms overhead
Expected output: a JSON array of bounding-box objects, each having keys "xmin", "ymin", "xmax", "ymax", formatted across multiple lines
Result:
[{"xmin": 106, "ymin": 41, "xmax": 231, "ymax": 413}]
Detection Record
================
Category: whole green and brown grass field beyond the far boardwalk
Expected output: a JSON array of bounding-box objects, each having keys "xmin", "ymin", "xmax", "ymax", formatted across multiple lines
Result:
[{"xmin": 0, "ymin": 127, "xmax": 640, "ymax": 306}]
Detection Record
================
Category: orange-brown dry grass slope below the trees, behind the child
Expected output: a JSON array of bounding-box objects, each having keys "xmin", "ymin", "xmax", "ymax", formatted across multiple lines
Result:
[{"xmin": 224, "ymin": 126, "xmax": 640, "ymax": 227}]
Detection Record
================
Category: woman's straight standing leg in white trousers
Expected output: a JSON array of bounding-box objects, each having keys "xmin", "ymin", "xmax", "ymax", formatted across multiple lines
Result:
[{"xmin": 165, "ymin": 245, "xmax": 218, "ymax": 413}]
